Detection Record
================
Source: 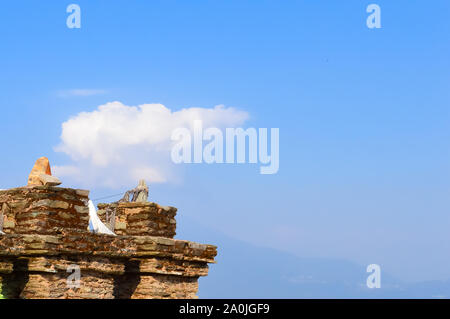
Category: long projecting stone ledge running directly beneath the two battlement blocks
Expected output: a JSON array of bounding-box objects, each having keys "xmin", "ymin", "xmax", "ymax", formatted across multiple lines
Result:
[{"xmin": 0, "ymin": 231, "xmax": 217, "ymax": 263}]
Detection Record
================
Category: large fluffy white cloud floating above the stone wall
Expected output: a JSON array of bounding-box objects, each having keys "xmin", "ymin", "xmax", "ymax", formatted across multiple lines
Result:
[{"xmin": 53, "ymin": 102, "xmax": 248, "ymax": 188}]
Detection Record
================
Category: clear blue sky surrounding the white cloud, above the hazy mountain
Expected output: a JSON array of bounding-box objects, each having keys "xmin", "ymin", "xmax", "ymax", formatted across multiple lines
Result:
[{"xmin": 0, "ymin": 0, "xmax": 450, "ymax": 296}]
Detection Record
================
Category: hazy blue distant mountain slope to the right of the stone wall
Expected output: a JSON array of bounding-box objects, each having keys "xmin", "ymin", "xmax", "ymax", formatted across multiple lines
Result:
[{"xmin": 177, "ymin": 217, "xmax": 450, "ymax": 298}]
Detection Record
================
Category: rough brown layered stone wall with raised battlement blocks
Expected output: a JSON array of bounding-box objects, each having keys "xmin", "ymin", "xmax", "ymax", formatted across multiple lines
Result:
[{"xmin": 0, "ymin": 186, "xmax": 217, "ymax": 298}]
